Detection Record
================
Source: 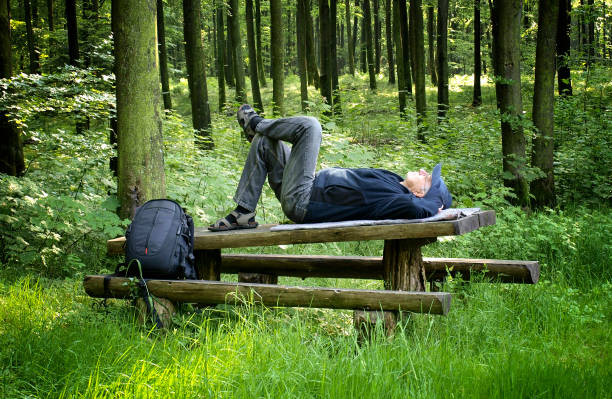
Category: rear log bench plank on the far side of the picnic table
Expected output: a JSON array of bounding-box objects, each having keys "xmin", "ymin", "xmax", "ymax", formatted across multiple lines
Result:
[{"xmin": 221, "ymin": 254, "xmax": 540, "ymax": 284}]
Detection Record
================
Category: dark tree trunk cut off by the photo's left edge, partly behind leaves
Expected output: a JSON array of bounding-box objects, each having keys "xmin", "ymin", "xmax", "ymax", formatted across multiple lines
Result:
[{"xmin": 0, "ymin": 0, "xmax": 25, "ymax": 176}]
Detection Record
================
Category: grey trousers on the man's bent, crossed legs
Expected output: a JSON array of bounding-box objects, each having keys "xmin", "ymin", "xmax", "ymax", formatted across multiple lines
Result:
[{"xmin": 234, "ymin": 116, "xmax": 321, "ymax": 223}]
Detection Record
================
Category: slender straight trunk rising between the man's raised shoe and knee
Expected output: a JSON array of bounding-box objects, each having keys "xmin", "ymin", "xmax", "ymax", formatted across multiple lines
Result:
[{"xmin": 270, "ymin": 0, "xmax": 285, "ymax": 115}]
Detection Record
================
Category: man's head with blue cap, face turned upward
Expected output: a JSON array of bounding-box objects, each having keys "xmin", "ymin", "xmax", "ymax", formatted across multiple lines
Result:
[{"xmin": 401, "ymin": 164, "xmax": 453, "ymax": 209}]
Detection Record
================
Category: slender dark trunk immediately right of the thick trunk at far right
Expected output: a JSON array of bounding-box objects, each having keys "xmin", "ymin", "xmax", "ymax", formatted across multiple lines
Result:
[{"xmin": 557, "ymin": 0, "xmax": 572, "ymax": 96}]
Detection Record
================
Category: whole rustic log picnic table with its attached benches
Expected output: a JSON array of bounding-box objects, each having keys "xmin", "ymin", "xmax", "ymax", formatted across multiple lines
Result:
[{"xmin": 84, "ymin": 211, "xmax": 539, "ymax": 330}]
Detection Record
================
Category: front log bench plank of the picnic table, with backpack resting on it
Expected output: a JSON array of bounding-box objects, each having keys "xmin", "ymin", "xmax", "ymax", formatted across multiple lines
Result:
[{"xmin": 83, "ymin": 275, "xmax": 451, "ymax": 315}]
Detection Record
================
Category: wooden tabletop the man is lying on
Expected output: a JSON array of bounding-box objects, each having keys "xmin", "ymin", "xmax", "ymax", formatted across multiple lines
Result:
[{"xmin": 107, "ymin": 210, "xmax": 495, "ymax": 255}]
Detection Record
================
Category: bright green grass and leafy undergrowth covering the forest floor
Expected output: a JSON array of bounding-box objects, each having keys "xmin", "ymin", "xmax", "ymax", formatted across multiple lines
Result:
[{"xmin": 0, "ymin": 71, "xmax": 612, "ymax": 398}]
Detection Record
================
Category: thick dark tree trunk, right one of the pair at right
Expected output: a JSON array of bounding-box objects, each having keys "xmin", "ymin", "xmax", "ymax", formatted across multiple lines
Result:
[{"xmin": 531, "ymin": 0, "xmax": 559, "ymax": 208}]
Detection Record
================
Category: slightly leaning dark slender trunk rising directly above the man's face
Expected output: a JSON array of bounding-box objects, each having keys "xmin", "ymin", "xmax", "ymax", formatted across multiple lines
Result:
[{"xmin": 410, "ymin": 0, "xmax": 426, "ymax": 141}]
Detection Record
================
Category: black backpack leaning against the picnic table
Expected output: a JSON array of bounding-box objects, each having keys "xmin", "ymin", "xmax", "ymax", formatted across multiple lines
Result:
[{"xmin": 125, "ymin": 199, "xmax": 197, "ymax": 279}]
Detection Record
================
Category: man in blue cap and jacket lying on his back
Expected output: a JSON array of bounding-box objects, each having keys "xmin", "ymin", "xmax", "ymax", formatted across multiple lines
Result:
[{"xmin": 208, "ymin": 104, "xmax": 452, "ymax": 231}]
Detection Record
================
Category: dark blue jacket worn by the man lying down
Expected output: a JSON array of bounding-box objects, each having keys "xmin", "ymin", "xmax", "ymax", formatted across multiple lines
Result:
[{"xmin": 304, "ymin": 168, "xmax": 442, "ymax": 223}]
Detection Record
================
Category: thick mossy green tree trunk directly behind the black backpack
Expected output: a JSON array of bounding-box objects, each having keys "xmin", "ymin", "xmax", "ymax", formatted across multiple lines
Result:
[{"xmin": 112, "ymin": 0, "xmax": 166, "ymax": 218}]
